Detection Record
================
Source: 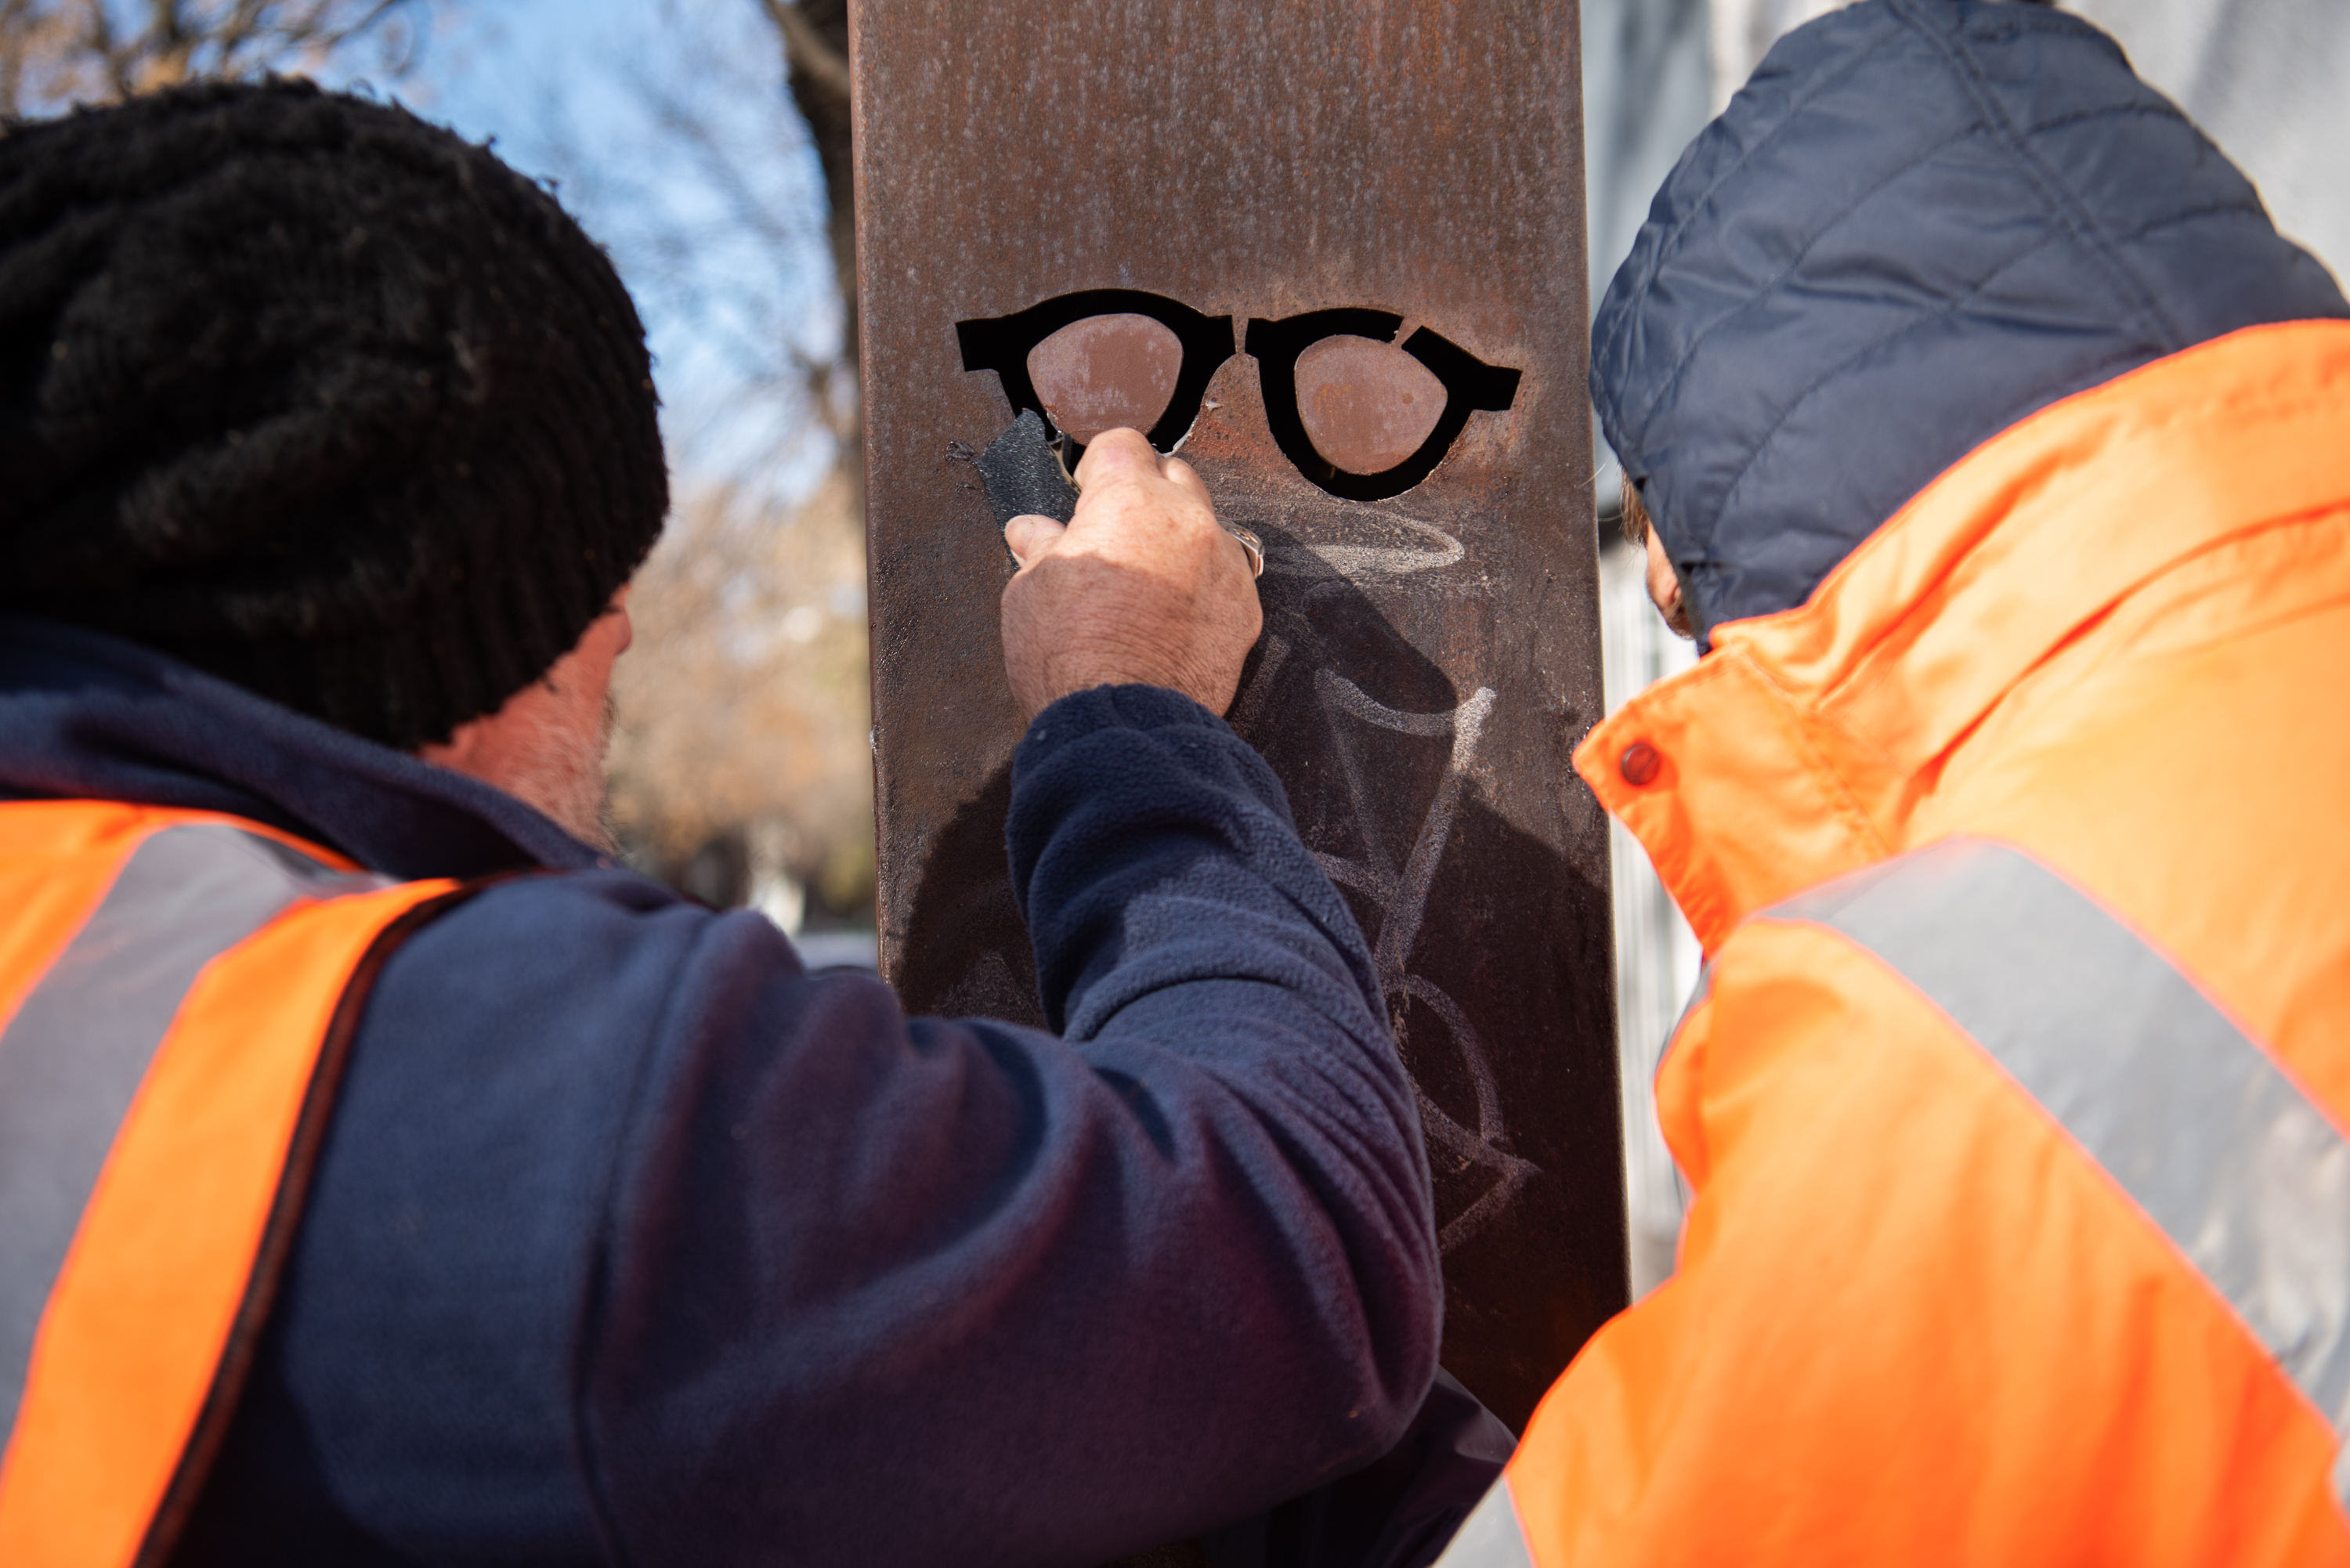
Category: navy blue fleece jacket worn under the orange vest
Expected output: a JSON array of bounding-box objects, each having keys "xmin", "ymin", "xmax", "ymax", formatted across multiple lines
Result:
[{"xmin": 0, "ymin": 620, "xmax": 1441, "ymax": 1568}]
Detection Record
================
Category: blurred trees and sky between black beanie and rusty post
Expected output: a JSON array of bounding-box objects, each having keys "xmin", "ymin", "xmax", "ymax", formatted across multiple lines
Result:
[{"xmin": 0, "ymin": 0, "xmax": 874, "ymax": 959}]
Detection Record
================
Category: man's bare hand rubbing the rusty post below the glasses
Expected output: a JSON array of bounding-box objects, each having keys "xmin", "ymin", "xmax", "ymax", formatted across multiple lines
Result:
[{"xmin": 1003, "ymin": 430, "xmax": 1264, "ymax": 719}]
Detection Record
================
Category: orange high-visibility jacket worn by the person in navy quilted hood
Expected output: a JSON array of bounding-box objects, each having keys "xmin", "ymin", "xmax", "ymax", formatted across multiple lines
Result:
[{"xmin": 1443, "ymin": 322, "xmax": 2350, "ymax": 1568}]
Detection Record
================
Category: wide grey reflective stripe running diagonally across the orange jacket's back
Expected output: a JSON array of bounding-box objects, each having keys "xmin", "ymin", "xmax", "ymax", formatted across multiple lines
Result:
[{"xmin": 1762, "ymin": 840, "xmax": 2350, "ymax": 1495}]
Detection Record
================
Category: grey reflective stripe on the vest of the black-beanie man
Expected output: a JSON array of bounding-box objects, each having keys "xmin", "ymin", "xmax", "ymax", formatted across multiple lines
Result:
[{"xmin": 0, "ymin": 823, "xmax": 390, "ymax": 1441}]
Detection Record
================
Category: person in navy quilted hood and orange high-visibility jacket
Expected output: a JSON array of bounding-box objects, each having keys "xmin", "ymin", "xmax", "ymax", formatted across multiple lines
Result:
[{"xmin": 1443, "ymin": 0, "xmax": 2350, "ymax": 1568}]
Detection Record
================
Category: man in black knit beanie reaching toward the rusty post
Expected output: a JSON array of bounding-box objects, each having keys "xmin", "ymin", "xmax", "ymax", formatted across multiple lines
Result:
[{"xmin": 0, "ymin": 85, "xmax": 1441, "ymax": 1563}]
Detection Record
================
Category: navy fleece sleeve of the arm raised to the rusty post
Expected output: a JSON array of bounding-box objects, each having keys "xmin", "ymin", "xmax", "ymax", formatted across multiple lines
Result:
[{"xmin": 583, "ymin": 686, "xmax": 1441, "ymax": 1566}]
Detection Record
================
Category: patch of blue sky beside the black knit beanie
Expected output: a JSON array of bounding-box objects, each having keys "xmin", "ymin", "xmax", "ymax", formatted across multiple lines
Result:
[{"xmin": 352, "ymin": 0, "xmax": 839, "ymax": 505}]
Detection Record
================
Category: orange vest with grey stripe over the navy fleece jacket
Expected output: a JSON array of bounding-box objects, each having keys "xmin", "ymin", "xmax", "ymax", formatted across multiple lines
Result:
[{"xmin": 0, "ymin": 802, "xmax": 461, "ymax": 1568}]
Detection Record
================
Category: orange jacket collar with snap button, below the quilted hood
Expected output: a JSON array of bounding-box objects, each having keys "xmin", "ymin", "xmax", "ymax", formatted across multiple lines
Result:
[{"xmin": 1574, "ymin": 322, "xmax": 2350, "ymax": 955}]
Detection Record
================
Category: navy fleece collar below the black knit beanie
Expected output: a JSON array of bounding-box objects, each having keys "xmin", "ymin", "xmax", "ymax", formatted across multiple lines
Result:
[{"xmin": 0, "ymin": 616, "xmax": 604, "ymax": 880}]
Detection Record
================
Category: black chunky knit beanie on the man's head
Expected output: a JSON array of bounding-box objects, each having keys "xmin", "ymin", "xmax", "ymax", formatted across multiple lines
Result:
[{"xmin": 0, "ymin": 82, "xmax": 667, "ymax": 750}]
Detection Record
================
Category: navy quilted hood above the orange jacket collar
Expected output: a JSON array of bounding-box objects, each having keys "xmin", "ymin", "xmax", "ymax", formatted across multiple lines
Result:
[{"xmin": 1591, "ymin": 0, "xmax": 2350, "ymax": 637}]
